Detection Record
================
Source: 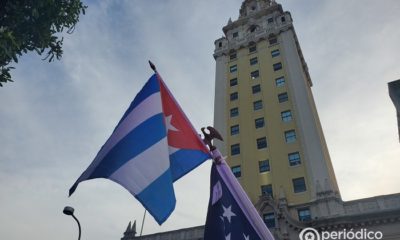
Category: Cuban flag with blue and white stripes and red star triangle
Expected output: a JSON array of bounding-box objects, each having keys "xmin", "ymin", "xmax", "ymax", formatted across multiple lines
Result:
[{"xmin": 69, "ymin": 73, "xmax": 211, "ymax": 225}]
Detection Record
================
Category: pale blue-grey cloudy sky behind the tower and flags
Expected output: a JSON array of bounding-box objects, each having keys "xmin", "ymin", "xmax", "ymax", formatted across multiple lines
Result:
[{"xmin": 0, "ymin": 0, "xmax": 400, "ymax": 240}]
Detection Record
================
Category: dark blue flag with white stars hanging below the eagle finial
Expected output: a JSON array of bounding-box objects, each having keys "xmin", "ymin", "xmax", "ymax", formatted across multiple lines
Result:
[{"xmin": 204, "ymin": 150, "xmax": 274, "ymax": 240}]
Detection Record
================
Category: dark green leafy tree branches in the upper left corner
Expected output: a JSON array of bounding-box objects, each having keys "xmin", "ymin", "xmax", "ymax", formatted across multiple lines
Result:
[{"xmin": 0, "ymin": 0, "xmax": 87, "ymax": 87}]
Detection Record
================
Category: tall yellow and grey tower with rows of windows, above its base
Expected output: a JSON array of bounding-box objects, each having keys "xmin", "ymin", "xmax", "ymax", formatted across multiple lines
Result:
[{"xmin": 214, "ymin": 0, "xmax": 340, "ymax": 206}]
